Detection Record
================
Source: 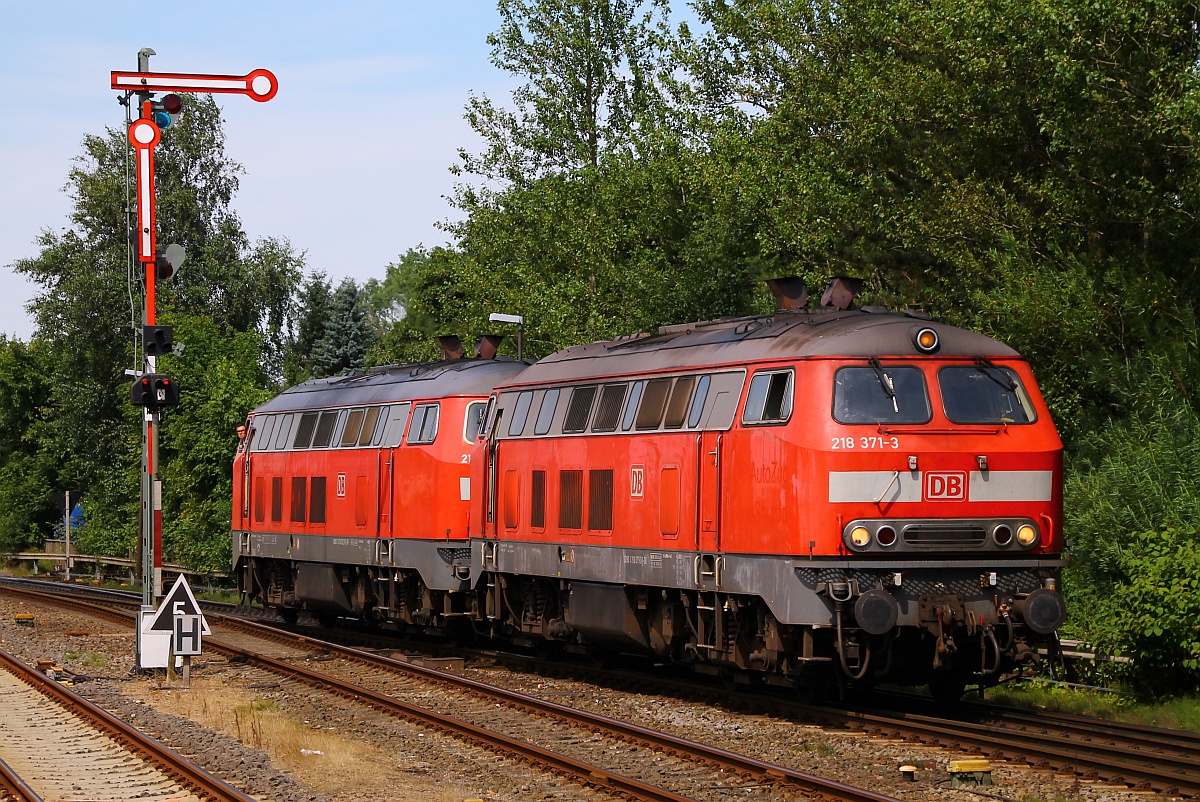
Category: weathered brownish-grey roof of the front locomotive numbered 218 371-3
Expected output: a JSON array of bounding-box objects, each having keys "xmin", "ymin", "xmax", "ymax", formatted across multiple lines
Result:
[{"xmin": 508, "ymin": 307, "xmax": 1020, "ymax": 383}]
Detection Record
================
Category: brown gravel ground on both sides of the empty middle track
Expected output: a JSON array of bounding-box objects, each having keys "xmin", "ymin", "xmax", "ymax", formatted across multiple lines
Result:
[{"xmin": 0, "ymin": 588, "xmax": 1166, "ymax": 802}]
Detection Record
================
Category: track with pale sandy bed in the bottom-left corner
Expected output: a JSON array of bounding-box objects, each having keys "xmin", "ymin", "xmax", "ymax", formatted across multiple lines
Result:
[{"xmin": 0, "ymin": 650, "xmax": 253, "ymax": 802}]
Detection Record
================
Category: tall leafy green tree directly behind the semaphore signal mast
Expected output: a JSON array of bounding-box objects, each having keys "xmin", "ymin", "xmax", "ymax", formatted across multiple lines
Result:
[{"xmin": 12, "ymin": 96, "xmax": 302, "ymax": 564}]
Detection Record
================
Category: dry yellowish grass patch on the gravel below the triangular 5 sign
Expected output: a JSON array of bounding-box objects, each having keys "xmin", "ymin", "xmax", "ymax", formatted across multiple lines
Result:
[{"xmin": 142, "ymin": 677, "xmax": 481, "ymax": 802}]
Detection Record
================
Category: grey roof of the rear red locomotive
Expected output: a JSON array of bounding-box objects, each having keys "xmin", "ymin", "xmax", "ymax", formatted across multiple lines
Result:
[{"xmin": 254, "ymin": 358, "xmax": 527, "ymax": 414}]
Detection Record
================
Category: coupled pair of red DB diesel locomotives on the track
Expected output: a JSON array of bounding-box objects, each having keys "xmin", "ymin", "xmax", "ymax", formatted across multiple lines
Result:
[{"xmin": 234, "ymin": 285, "xmax": 1066, "ymax": 695}]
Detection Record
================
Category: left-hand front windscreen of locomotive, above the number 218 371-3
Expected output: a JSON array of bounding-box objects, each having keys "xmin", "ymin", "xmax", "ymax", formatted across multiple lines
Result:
[{"xmin": 833, "ymin": 361, "xmax": 932, "ymax": 424}]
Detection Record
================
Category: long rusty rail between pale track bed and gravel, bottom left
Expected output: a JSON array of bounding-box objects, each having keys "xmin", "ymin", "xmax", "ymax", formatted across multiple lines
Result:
[{"xmin": 0, "ymin": 648, "xmax": 254, "ymax": 802}]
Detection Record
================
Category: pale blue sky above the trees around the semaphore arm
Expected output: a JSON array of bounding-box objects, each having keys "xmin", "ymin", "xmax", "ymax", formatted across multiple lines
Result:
[{"xmin": 0, "ymin": 0, "xmax": 515, "ymax": 340}]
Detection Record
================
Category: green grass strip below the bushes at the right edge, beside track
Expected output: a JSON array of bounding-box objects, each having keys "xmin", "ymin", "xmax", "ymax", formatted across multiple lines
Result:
[{"xmin": 986, "ymin": 681, "xmax": 1200, "ymax": 732}]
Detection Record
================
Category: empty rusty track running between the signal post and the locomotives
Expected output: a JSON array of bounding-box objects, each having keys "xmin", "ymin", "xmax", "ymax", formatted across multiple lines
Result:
[{"xmin": 0, "ymin": 578, "xmax": 894, "ymax": 802}]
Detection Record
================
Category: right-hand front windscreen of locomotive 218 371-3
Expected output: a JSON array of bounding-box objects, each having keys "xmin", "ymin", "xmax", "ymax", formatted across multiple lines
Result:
[{"xmin": 937, "ymin": 361, "xmax": 1037, "ymax": 424}]
